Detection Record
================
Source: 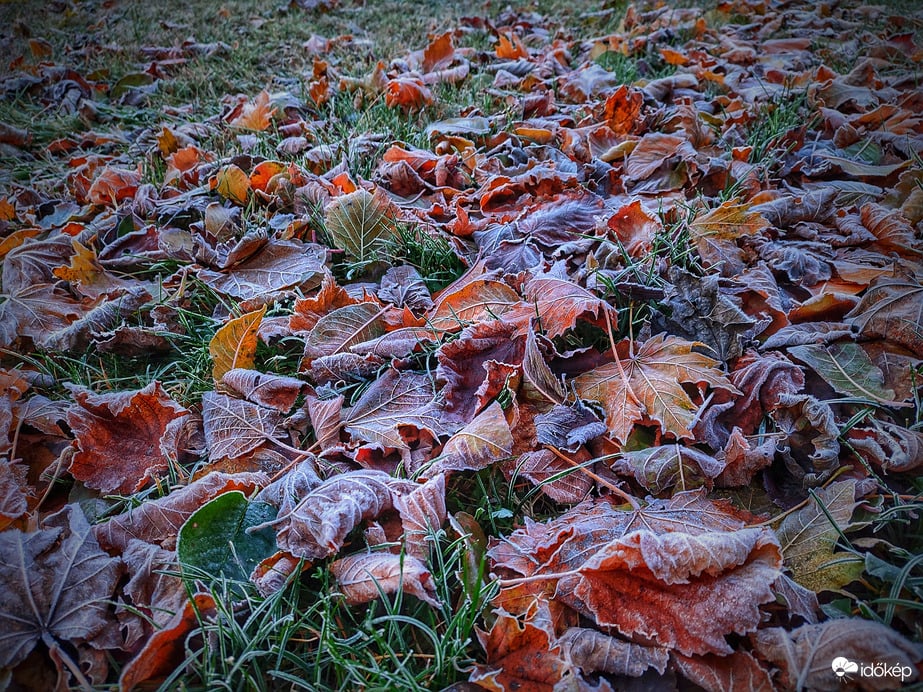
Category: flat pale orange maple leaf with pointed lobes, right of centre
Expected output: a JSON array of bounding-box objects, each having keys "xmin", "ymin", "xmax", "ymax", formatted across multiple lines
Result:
[{"xmin": 574, "ymin": 334, "xmax": 739, "ymax": 443}]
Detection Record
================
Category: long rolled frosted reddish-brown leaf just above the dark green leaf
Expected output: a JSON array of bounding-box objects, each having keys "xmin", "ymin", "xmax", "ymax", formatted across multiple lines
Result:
[{"xmin": 93, "ymin": 472, "xmax": 269, "ymax": 551}]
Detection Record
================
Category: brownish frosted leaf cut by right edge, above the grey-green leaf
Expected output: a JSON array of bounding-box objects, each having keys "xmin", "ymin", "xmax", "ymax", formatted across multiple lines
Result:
[{"xmin": 846, "ymin": 278, "xmax": 923, "ymax": 353}]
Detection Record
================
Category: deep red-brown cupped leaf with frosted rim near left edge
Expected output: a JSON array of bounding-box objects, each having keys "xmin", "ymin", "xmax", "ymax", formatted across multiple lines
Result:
[{"xmin": 67, "ymin": 382, "xmax": 187, "ymax": 494}]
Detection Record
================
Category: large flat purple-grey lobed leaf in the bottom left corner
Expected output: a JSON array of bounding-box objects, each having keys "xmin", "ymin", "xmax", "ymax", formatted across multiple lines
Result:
[{"xmin": 0, "ymin": 505, "xmax": 120, "ymax": 669}]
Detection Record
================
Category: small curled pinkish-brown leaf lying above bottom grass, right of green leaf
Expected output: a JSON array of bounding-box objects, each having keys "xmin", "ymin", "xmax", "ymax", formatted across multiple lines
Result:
[{"xmin": 330, "ymin": 552, "xmax": 442, "ymax": 608}]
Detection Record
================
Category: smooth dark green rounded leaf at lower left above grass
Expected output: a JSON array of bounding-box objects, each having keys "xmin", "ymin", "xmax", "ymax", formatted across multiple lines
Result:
[{"xmin": 176, "ymin": 490, "xmax": 276, "ymax": 581}]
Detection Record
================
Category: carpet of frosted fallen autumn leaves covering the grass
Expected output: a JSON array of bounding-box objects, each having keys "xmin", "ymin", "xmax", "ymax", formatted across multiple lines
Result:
[{"xmin": 0, "ymin": 0, "xmax": 923, "ymax": 690}]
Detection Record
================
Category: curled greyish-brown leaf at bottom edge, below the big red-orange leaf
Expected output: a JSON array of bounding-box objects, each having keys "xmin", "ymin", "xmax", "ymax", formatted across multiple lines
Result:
[{"xmin": 555, "ymin": 627, "xmax": 670, "ymax": 678}]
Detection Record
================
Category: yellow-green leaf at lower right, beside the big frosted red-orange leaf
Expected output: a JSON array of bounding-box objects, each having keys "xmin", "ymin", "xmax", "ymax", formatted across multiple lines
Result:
[{"xmin": 777, "ymin": 480, "xmax": 865, "ymax": 591}]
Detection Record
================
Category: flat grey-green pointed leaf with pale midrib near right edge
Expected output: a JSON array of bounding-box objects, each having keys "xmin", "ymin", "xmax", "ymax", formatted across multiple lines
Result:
[{"xmin": 788, "ymin": 341, "xmax": 900, "ymax": 406}]
